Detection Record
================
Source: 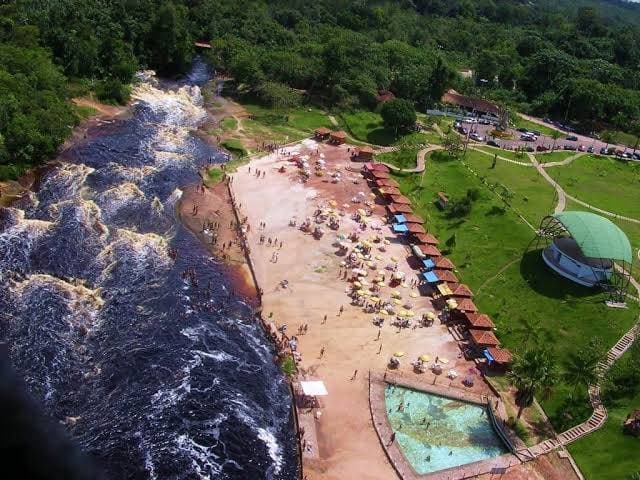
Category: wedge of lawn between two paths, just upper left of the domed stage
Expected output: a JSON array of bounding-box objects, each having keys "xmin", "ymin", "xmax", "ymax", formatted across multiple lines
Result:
[{"xmin": 466, "ymin": 150, "xmax": 555, "ymax": 227}]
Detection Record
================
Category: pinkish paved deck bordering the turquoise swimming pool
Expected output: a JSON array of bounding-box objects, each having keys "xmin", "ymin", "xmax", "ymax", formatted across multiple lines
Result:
[{"xmin": 369, "ymin": 372, "xmax": 522, "ymax": 480}]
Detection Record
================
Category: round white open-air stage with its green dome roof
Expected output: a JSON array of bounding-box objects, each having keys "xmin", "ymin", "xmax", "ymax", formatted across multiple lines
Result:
[{"xmin": 538, "ymin": 212, "xmax": 633, "ymax": 303}]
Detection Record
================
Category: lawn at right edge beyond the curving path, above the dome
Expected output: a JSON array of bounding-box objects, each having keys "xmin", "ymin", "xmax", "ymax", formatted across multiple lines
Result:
[{"xmin": 553, "ymin": 155, "xmax": 640, "ymax": 219}]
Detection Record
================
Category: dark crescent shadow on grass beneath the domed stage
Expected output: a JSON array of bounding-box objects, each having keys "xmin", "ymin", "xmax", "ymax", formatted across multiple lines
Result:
[{"xmin": 520, "ymin": 249, "xmax": 601, "ymax": 303}]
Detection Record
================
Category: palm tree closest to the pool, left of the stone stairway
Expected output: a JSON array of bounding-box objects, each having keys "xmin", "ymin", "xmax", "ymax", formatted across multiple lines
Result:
[{"xmin": 509, "ymin": 349, "xmax": 557, "ymax": 418}]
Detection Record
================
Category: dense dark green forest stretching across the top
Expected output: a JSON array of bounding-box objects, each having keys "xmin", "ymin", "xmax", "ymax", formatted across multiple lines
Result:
[{"xmin": 0, "ymin": 0, "xmax": 640, "ymax": 174}]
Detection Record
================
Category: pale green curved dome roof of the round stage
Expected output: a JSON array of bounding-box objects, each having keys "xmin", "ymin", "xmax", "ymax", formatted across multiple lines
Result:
[{"xmin": 553, "ymin": 212, "xmax": 633, "ymax": 263}]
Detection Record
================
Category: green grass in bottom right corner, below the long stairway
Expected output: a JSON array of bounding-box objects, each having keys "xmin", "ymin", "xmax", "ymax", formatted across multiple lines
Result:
[{"xmin": 568, "ymin": 346, "xmax": 640, "ymax": 480}]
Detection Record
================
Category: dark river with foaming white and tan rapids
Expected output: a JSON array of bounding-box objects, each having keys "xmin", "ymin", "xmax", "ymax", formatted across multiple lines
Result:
[{"xmin": 0, "ymin": 62, "xmax": 298, "ymax": 480}]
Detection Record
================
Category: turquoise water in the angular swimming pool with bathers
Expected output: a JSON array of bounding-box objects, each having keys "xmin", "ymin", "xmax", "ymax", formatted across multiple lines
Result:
[{"xmin": 385, "ymin": 385, "xmax": 508, "ymax": 474}]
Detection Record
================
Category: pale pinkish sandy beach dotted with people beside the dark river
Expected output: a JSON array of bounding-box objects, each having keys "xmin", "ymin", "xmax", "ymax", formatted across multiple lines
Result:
[{"xmin": 231, "ymin": 140, "xmax": 496, "ymax": 480}]
